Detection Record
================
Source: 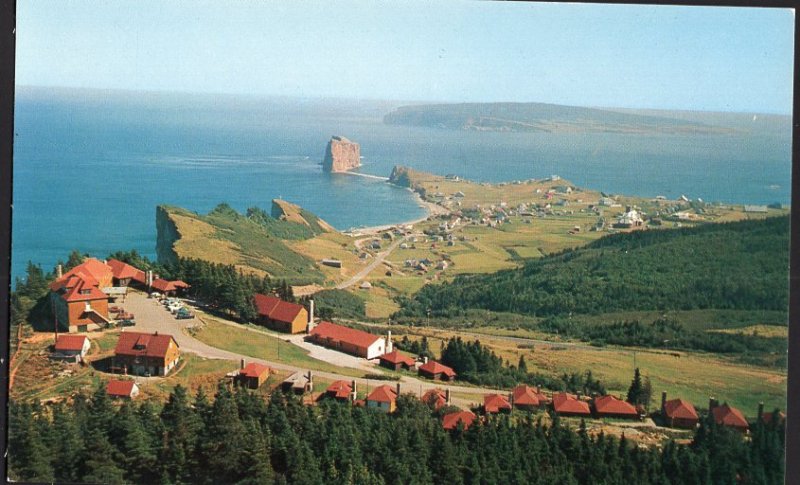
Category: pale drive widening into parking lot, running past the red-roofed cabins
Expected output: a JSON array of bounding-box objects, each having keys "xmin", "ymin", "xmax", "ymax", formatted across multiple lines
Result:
[{"xmin": 124, "ymin": 292, "xmax": 498, "ymax": 406}]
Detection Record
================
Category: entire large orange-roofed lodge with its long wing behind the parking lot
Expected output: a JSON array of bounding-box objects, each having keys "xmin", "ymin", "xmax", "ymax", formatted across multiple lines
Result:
[{"xmin": 50, "ymin": 258, "xmax": 189, "ymax": 333}]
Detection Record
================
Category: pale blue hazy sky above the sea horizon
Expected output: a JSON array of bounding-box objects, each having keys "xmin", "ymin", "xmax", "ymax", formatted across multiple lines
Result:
[{"xmin": 16, "ymin": 0, "xmax": 794, "ymax": 114}]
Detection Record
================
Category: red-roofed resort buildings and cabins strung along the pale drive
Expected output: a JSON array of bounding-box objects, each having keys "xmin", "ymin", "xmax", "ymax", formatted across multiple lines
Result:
[{"xmin": 12, "ymin": 258, "xmax": 785, "ymax": 446}]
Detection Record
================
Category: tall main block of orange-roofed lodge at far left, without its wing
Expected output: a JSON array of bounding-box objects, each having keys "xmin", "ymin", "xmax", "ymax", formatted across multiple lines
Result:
[{"xmin": 50, "ymin": 258, "xmax": 113, "ymax": 332}]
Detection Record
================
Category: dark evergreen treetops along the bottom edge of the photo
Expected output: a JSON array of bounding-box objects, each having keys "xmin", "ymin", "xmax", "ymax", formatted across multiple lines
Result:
[{"xmin": 9, "ymin": 384, "xmax": 784, "ymax": 484}]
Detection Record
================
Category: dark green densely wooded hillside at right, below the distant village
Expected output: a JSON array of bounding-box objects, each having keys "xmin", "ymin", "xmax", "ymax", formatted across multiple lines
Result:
[{"xmin": 399, "ymin": 216, "xmax": 789, "ymax": 317}]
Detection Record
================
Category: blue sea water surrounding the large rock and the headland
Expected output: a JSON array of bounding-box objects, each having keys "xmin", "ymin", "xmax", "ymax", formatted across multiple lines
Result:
[{"xmin": 12, "ymin": 88, "xmax": 791, "ymax": 277}]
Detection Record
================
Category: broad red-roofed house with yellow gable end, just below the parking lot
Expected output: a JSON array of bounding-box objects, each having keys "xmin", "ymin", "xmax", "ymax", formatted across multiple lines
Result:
[{"xmin": 112, "ymin": 332, "xmax": 181, "ymax": 376}]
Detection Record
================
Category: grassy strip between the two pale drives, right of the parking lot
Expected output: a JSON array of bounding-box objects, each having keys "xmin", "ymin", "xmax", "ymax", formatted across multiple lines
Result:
[{"xmin": 192, "ymin": 317, "xmax": 364, "ymax": 377}]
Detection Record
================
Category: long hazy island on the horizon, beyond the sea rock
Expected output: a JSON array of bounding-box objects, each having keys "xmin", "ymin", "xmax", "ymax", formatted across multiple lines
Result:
[{"xmin": 383, "ymin": 103, "xmax": 731, "ymax": 134}]
